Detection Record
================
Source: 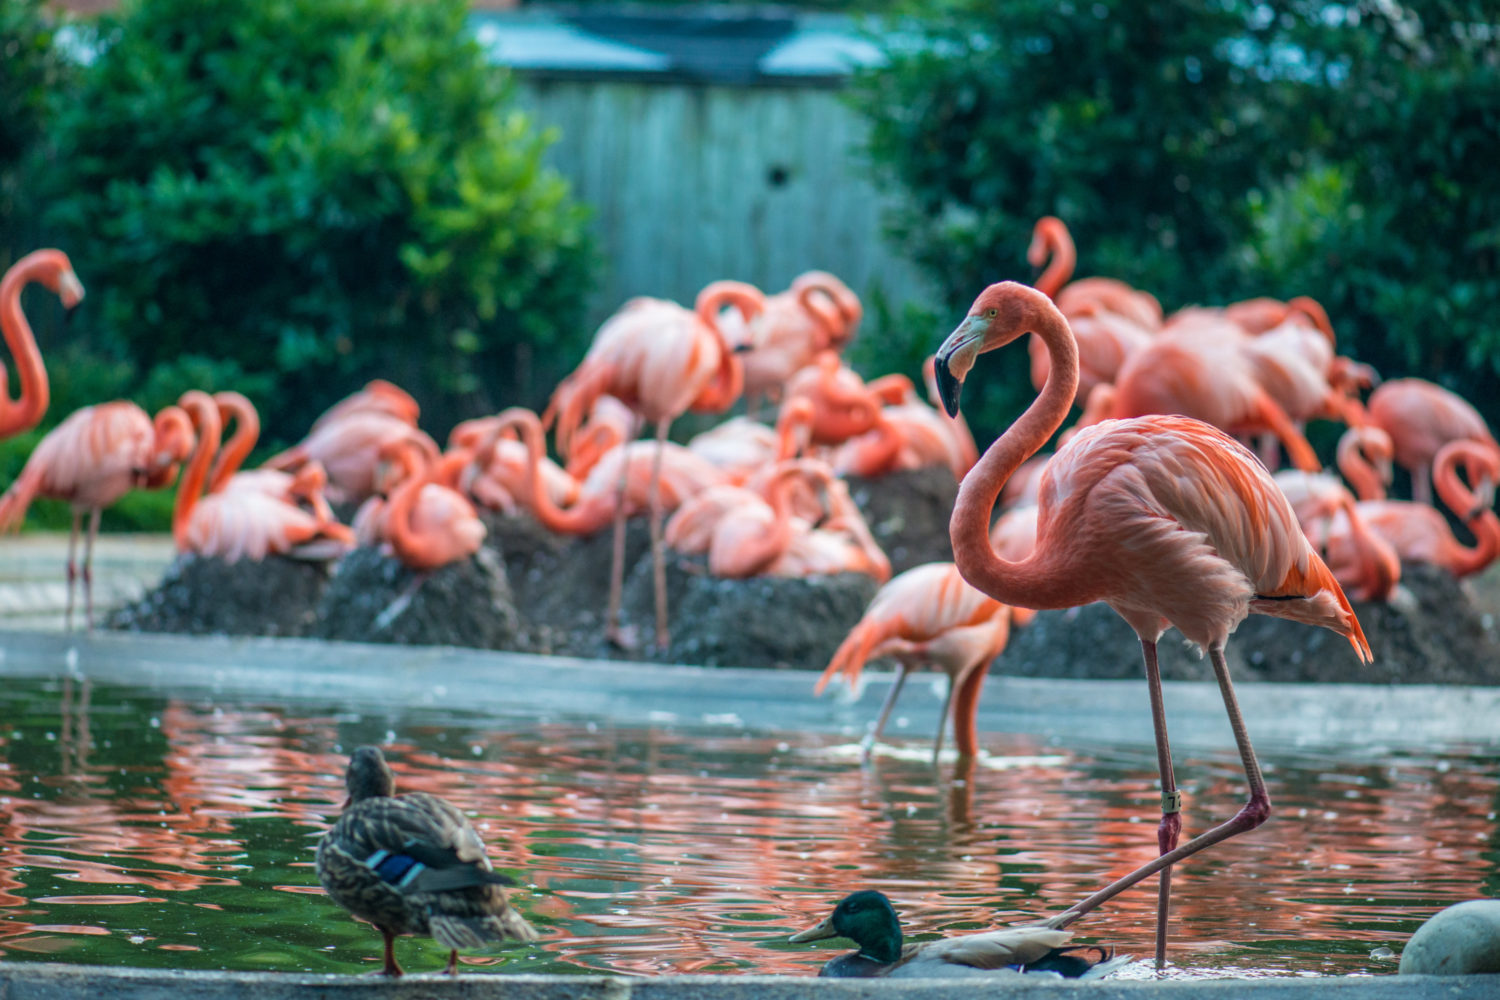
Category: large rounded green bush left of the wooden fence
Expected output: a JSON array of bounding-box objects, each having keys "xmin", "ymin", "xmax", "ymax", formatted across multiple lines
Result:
[{"xmin": 50, "ymin": 0, "xmax": 591, "ymax": 438}]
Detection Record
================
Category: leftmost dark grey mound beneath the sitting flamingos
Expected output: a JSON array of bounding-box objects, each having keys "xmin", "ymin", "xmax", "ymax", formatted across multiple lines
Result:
[{"xmin": 105, "ymin": 555, "xmax": 330, "ymax": 636}]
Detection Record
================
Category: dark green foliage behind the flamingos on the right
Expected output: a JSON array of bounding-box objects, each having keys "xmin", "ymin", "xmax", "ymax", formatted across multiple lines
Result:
[{"xmin": 854, "ymin": 0, "xmax": 1500, "ymax": 434}]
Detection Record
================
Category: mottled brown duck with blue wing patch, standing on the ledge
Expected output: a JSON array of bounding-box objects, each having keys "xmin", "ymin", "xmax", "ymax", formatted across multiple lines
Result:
[{"xmin": 318, "ymin": 747, "xmax": 537, "ymax": 976}]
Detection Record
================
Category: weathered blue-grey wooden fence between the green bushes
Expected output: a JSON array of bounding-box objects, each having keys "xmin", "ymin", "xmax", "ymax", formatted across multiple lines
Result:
[{"xmin": 521, "ymin": 76, "xmax": 924, "ymax": 328}]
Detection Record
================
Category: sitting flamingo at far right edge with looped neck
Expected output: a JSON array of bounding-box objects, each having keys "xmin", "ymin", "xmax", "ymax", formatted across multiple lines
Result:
[{"xmin": 1329, "ymin": 439, "xmax": 1500, "ymax": 577}]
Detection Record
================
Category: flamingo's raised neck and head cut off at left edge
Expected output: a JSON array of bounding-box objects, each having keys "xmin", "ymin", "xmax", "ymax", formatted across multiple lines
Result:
[{"xmin": 0, "ymin": 250, "xmax": 84, "ymax": 438}]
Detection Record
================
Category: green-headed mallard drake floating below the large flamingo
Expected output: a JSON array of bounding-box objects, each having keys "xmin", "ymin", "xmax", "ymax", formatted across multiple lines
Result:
[{"xmin": 791, "ymin": 889, "xmax": 1131, "ymax": 979}]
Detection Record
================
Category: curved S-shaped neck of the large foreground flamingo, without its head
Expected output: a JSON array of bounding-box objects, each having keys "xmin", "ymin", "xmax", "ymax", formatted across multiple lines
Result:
[{"xmin": 948, "ymin": 285, "xmax": 1080, "ymax": 609}]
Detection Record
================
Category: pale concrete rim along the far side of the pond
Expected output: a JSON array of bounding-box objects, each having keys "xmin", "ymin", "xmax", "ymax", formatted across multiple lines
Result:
[{"xmin": 0, "ymin": 630, "xmax": 1500, "ymax": 754}]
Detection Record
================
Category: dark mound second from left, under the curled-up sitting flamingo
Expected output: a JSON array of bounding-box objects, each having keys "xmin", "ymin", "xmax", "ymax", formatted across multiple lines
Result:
[{"xmin": 309, "ymin": 549, "xmax": 519, "ymax": 649}]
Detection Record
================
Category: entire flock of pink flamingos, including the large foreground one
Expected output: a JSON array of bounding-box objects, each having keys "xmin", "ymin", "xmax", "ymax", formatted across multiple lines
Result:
[{"xmin": 0, "ymin": 217, "xmax": 1500, "ymax": 963}]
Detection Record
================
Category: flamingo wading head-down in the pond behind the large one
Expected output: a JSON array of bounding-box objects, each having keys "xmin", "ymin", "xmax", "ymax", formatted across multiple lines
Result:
[{"xmin": 813, "ymin": 562, "xmax": 1011, "ymax": 765}]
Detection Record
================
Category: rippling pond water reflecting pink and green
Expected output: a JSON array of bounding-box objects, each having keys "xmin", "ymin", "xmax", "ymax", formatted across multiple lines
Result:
[{"xmin": 0, "ymin": 679, "xmax": 1500, "ymax": 978}]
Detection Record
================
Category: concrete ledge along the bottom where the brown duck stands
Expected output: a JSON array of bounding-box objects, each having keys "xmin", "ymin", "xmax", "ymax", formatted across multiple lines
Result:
[{"xmin": 0, "ymin": 963, "xmax": 1500, "ymax": 1000}]
